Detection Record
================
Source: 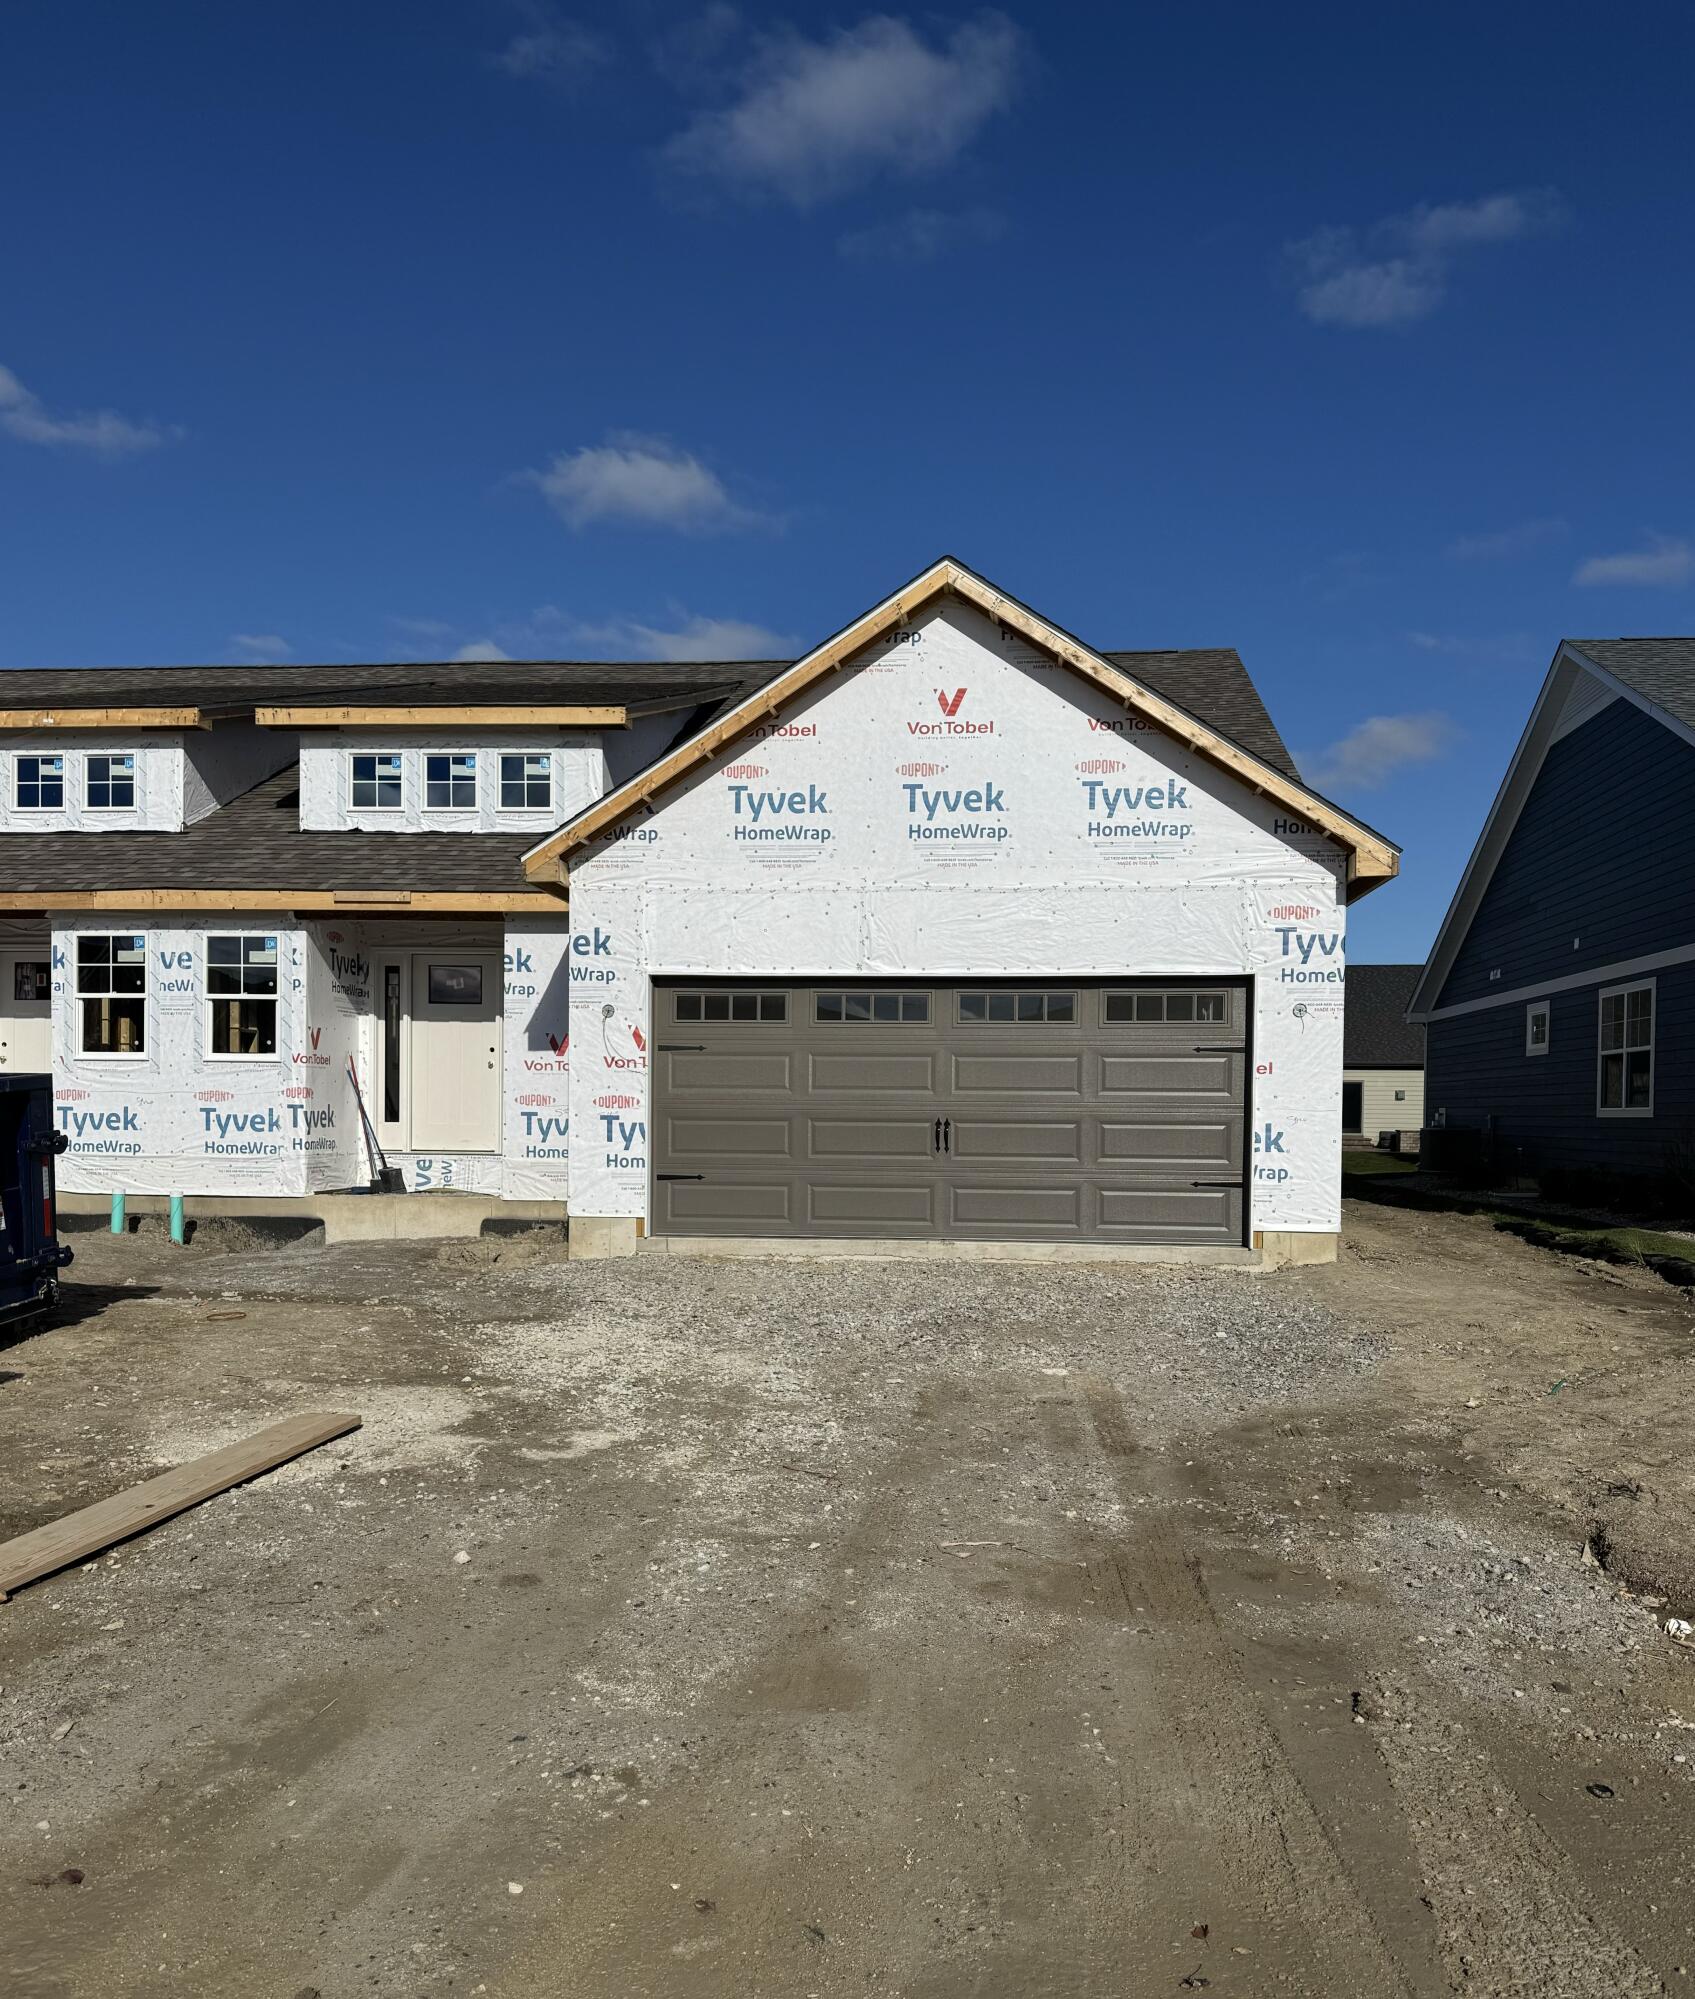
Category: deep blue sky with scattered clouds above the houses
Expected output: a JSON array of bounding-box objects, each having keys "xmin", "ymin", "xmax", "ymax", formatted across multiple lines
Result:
[{"xmin": 0, "ymin": 0, "xmax": 1695, "ymax": 958}]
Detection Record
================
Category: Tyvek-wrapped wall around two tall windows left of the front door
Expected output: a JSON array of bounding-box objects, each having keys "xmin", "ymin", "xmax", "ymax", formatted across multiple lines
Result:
[{"xmin": 52, "ymin": 912, "xmax": 368, "ymax": 1193}]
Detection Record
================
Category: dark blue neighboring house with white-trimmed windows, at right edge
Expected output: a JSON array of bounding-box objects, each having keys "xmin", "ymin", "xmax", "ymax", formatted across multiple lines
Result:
[{"xmin": 1409, "ymin": 638, "xmax": 1695, "ymax": 1177}]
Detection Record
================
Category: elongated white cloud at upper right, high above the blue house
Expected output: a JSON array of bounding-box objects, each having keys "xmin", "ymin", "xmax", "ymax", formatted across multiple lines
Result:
[{"xmin": 1285, "ymin": 188, "xmax": 1563, "ymax": 328}]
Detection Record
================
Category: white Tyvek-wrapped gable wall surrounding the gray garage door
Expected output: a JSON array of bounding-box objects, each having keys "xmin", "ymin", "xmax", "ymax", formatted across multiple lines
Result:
[{"xmin": 568, "ymin": 606, "xmax": 1343, "ymax": 1231}]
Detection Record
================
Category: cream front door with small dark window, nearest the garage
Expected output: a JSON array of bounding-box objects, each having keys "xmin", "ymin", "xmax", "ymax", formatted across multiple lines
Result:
[{"xmin": 410, "ymin": 952, "xmax": 502, "ymax": 1153}]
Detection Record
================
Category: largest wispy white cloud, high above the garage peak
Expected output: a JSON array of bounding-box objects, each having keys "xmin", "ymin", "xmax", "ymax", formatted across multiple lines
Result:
[{"xmin": 664, "ymin": 14, "xmax": 1021, "ymax": 208}]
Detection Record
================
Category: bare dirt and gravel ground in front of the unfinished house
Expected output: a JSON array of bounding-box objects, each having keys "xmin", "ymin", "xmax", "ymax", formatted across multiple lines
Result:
[{"xmin": 0, "ymin": 1207, "xmax": 1695, "ymax": 1999}]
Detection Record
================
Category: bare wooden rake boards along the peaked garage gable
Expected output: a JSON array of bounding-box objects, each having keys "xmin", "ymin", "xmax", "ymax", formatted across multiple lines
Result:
[{"xmin": 524, "ymin": 556, "xmax": 1399, "ymax": 902}]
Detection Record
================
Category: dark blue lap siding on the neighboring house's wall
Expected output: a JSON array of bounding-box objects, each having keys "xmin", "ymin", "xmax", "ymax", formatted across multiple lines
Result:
[{"xmin": 1425, "ymin": 700, "xmax": 1695, "ymax": 1173}]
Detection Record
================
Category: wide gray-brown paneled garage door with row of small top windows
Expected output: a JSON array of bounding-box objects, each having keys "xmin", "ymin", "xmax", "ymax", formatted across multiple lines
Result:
[{"xmin": 652, "ymin": 980, "xmax": 1247, "ymax": 1245}]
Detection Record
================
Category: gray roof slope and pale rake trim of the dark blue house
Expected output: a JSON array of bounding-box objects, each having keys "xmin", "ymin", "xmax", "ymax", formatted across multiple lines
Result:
[{"xmin": 1411, "ymin": 638, "xmax": 1695, "ymax": 1019}]
